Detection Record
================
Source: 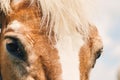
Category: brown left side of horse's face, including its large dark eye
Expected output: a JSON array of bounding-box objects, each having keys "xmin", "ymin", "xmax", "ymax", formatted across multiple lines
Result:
[{"xmin": 0, "ymin": 2, "xmax": 61, "ymax": 80}]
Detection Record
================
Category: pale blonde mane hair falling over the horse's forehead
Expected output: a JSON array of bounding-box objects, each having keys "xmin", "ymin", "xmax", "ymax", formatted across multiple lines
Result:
[{"xmin": 0, "ymin": 0, "xmax": 92, "ymax": 39}]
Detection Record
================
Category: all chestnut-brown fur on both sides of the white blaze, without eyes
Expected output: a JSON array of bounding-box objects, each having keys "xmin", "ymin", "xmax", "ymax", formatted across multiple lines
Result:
[{"xmin": 0, "ymin": 0, "xmax": 102, "ymax": 80}]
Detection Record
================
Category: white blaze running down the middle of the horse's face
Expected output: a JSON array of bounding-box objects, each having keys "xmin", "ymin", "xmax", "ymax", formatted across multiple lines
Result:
[{"xmin": 56, "ymin": 33, "xmax": 84, "ymax": 80}]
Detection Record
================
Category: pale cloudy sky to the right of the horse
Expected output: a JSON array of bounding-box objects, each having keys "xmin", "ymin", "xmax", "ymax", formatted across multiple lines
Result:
[{"xmin": 90, "ymin": 0, "xmax": 120, "ymax": 80}]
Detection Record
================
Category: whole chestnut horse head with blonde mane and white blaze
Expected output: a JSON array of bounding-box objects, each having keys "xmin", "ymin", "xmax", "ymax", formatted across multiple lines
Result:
[{"xmin": 0, "ymin": 0, "xmax": 103, "ymax": 80}]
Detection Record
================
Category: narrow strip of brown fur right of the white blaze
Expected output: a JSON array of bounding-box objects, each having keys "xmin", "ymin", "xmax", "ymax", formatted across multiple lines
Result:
[{"xmin": 80, "ymin": 25, "xmax": 103, "ymax": 80}]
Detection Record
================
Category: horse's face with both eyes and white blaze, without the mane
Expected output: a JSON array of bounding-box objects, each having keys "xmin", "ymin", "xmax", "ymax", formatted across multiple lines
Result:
[{"xmin": 0, "ymin": 0, "xmax": 102, "ymax": 80}]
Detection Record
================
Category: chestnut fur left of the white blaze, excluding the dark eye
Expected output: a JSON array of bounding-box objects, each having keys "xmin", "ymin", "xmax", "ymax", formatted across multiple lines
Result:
[{"xmin": 1, "ymin": 1, "xmax": 61, "ymax": 80}]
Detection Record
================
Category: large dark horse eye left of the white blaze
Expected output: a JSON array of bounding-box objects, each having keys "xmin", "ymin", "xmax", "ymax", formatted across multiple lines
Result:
[{"xmin": 6, "ymin": 37, "xmax": 26, "ymax": 61}]
